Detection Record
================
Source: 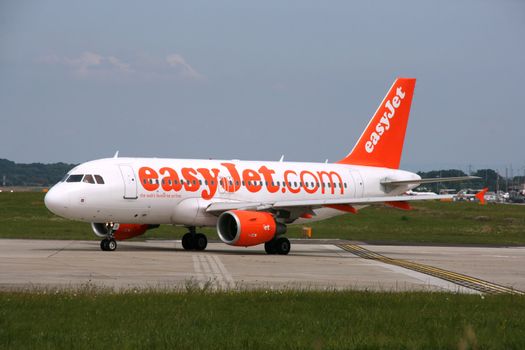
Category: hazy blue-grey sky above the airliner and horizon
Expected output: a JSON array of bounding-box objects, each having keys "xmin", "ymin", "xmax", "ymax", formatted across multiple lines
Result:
[{"xmin": 0, "ymin": 0, "xmax": 525, "ymax": 173}]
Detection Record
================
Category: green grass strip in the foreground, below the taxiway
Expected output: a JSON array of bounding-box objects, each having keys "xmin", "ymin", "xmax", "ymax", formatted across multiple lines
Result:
[{"xmin": 0, "ymin": 290, "xmax": 525, "ymax": 349}]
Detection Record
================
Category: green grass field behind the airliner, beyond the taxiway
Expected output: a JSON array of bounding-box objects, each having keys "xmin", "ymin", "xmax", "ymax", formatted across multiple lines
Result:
[{"xmin": 0, "ymin": 192, "xmax": 525, "ymax": 245}]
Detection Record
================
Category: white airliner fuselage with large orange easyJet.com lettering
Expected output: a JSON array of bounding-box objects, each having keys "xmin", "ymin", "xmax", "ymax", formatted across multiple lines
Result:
[{"xmin": 45, "ymin": 158, "xmax": 420, "ymax": 226}]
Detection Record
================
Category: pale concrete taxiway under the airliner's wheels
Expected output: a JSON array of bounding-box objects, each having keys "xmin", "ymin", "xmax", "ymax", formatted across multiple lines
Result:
[{"xmin": 0, "ymin": 239, "xmax": 525, "ymax": 293}]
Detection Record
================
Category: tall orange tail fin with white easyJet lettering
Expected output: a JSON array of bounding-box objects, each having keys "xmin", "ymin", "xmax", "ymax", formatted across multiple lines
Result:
[{"xmin": 337, "ymin": 78, "xmax": 416, "ymax": 169}]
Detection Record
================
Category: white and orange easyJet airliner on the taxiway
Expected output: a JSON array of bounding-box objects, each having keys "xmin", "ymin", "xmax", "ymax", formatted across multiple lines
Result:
[{"xmin": 45, "ymin": 78, "xmax": 477, "ymax": 255}]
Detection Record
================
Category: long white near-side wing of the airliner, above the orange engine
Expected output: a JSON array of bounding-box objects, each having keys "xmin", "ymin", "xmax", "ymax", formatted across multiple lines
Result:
[{"xmin": 206, "ymin": 194, "xmax": 454, "ymax": 214}]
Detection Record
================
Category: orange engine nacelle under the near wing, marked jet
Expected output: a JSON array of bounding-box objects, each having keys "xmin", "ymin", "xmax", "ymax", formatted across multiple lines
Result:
[{"xmin": 217, "ymin": 210, "xmax": 286, "ymax": 247}]
